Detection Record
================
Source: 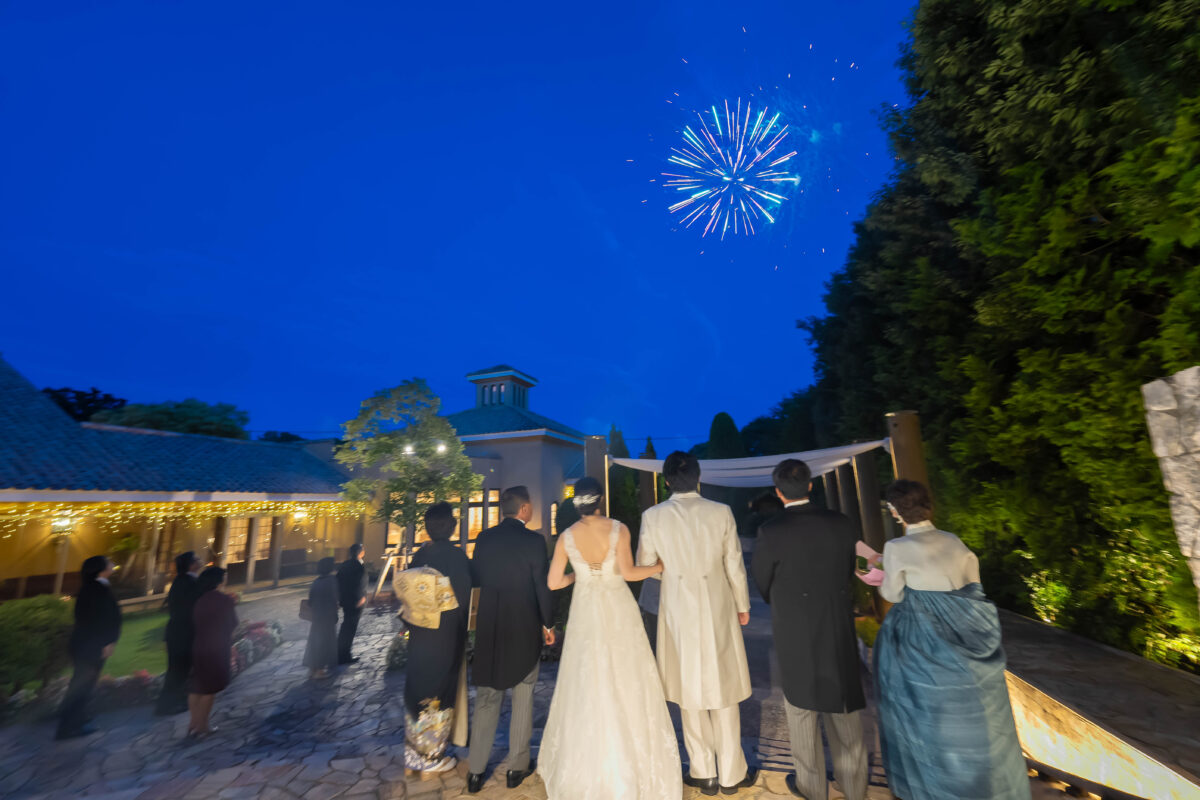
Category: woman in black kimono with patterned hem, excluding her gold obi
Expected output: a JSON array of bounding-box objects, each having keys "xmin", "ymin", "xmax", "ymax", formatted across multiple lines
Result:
[{"xmin": 404, "ymin": 503, "xmax": 470, "ymax": 774}]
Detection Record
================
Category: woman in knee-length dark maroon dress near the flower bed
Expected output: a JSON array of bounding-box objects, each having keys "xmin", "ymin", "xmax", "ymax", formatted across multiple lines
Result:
[{"xmin": 187, "ymin": 566, "xmax": 238, "ymax": 736}]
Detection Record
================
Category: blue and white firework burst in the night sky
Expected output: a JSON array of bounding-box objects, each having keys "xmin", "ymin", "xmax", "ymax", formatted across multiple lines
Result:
[{"xmin": 662, "ymin": 97, "xmax": 800, "ymax": 240}]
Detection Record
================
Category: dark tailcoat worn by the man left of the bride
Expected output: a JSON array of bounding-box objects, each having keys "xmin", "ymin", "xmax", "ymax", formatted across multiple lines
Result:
[{"xmin": 470, "ymin": 517, "xmax": 554, "ymax": 688}]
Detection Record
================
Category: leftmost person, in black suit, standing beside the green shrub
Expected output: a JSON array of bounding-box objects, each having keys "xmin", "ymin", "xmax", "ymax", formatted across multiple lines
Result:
[{"xmin": 55, "ymin": 555, "xmax": 121, "ymax": 739}]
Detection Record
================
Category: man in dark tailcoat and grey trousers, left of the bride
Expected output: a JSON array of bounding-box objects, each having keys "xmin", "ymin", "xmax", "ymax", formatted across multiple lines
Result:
[{"xmin": 467, "ymin": 486, "xmax": 554, "ymax": 793}]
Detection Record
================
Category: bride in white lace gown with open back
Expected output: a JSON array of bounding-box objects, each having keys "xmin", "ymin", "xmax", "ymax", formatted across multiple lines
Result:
[{"xmin": 538, "ymin": 477, "xmax": 683, "ymax": 800}]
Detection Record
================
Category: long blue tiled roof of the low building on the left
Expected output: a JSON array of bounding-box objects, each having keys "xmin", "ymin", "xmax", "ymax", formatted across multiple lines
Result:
[{"xmin": 0, "ymin": 359, "xmax": 346, "ymax": 494}]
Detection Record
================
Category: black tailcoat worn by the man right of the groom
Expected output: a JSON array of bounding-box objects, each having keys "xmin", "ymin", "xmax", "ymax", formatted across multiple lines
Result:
[{"xmin": 750, "ymin": 504, "xmax": 866, "ymax": 712}]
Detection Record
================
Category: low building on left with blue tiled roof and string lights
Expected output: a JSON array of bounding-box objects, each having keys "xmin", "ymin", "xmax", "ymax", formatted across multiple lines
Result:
[{"xmin": 0, "ymin": 359, "xmax": 364, "ymax": 599}]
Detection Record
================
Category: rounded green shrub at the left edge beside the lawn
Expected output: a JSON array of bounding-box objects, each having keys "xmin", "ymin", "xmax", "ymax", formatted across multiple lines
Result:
[{"xmin": 0, "ymin": 595, "xmax": 74, "ymax": 697}]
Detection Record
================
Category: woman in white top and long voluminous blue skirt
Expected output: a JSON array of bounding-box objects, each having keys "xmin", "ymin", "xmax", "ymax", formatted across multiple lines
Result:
[{"xmin": 875, "ymin": 481, "xmax": 1030, "ymax": 800}]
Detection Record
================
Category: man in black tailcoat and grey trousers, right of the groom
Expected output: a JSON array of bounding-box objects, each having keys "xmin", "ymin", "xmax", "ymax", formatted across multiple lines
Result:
[{"xmin": 750, "ymin": 458, "xmax": 866, "ymax": 800}]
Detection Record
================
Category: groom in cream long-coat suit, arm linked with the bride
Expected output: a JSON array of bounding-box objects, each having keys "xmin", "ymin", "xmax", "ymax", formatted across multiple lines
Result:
[{"xmin": 637, "ymin": 451, "xmax": 757, "ymax": 795}]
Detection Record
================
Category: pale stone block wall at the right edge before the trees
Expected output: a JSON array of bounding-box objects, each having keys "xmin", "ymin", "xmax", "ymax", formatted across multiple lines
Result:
[{"xmin": 1141, "ymin": 366, "xmax": 1200, "ymax": 604}]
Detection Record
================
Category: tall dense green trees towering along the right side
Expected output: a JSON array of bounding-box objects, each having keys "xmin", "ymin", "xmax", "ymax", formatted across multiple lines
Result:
[{"xmin": 763, "ymin": 0, "xmax": 1200, "ymax": 669}]
